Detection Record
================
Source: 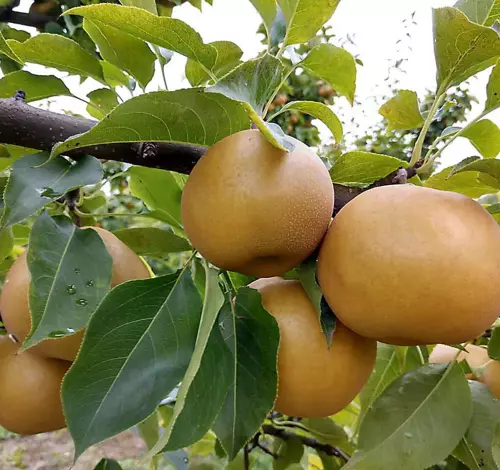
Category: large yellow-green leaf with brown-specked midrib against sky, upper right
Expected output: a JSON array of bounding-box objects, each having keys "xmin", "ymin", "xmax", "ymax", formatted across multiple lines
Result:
[{"xmin": 434, "ymin": 8, "xmax": 500, "ymax": 92}]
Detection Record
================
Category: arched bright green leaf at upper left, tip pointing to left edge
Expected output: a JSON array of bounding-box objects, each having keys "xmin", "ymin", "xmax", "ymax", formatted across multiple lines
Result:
[{"xmin": 8, "ymin": 33, "xmax": 104, "ymax": 82}]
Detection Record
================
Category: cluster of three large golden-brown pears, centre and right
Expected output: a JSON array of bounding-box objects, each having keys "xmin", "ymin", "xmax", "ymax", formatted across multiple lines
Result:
[{"xmin": 182, "ymin": 130, "xmax": 500, "ymax": 417}]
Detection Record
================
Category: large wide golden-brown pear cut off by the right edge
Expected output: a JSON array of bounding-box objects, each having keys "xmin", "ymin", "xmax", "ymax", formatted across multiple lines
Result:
[{"xmin": 318, "ymin": 184, "xmax": 500, "ymax": 345}]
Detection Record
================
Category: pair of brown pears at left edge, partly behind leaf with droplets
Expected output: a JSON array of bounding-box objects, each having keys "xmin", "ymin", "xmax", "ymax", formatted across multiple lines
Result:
[{"xmin": 0, "ymin": 227, "xmax": 150, "ymax": 435}]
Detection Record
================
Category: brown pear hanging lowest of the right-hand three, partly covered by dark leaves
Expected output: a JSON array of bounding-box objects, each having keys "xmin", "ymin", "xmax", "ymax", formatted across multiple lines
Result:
[{"xmin": 250, "ymin": 278, "xmax": 377, "ymax": 418}]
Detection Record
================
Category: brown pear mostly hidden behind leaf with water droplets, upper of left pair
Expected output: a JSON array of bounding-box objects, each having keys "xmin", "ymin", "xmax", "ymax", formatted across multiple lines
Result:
[{"xmin": 0, "ymin": 227, "xmax": 150, "ymax": 361}]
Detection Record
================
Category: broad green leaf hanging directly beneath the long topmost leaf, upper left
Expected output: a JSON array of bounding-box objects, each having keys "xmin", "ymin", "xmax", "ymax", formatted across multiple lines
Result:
[{"xmin": 83, "ymin": 18, "xmax": 156, "ymax": 88}]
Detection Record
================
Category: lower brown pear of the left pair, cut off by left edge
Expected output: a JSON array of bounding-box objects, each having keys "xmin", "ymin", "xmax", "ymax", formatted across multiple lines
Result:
[{"xmin": 0, "ymin": 336, "xmax": 71, "ymax": 435}]
